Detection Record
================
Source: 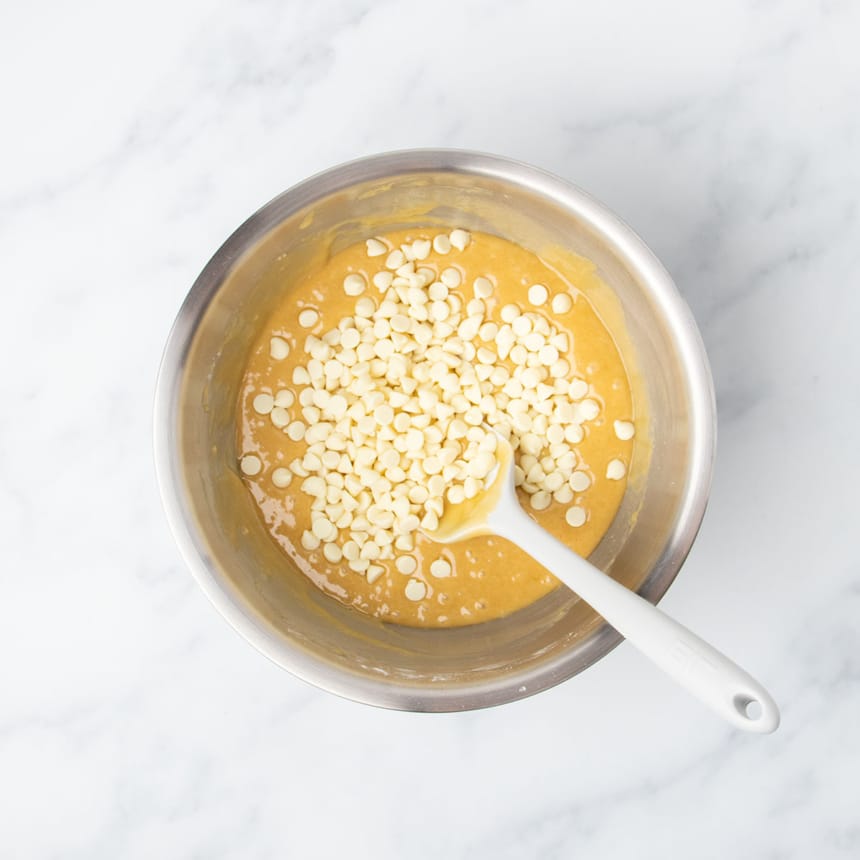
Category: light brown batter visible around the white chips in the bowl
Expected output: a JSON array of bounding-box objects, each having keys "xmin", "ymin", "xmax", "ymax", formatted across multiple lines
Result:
[{"xmin": 237, "ymin": 228, "xmax": 634, "ymax": 627}]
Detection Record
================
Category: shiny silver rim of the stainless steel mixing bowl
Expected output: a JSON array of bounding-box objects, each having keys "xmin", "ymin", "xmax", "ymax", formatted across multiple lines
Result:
[{"xmin": 153, "ymin": 148, "xmax": 717, "ymax": 712}]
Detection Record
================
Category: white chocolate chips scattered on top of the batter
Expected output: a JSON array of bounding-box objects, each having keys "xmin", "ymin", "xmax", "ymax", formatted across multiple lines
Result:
[{"xmin": 241, "ymin": 229, "xmax": 632, "ymax": 600}]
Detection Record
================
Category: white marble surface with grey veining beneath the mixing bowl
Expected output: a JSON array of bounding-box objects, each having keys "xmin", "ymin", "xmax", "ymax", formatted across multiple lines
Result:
[{"xmin": 0, "ymin": 0, "xmax": 860, "ymax": 860}]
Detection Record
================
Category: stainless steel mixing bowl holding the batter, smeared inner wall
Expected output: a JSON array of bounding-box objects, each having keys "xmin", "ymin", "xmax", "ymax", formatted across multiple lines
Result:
[{"xmin": 155, "ymin": 150, "xmax": 716, "ymax": 711}]
